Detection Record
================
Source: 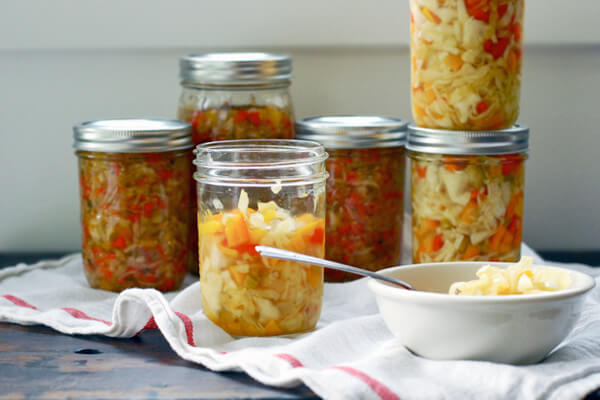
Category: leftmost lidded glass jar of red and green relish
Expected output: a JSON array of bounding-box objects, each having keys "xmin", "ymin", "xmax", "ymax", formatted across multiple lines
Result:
[{"xmin": 73, "ymin": 119, "xmax": 194, "ymax": 291}]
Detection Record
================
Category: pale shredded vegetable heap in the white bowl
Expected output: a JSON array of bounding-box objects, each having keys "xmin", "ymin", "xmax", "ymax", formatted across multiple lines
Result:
[{"xmin": 448, "ymin": 257, "xmax": 572, "ymax": 296}]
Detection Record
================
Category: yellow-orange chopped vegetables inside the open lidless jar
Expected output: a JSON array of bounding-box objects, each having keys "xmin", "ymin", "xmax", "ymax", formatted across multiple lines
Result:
[{"xmin": 198, "ymin": 190, "xmax": 325, "ymax": 336}]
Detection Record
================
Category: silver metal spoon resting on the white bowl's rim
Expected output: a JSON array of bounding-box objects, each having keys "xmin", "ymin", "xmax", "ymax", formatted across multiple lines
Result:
[{"xmin": 254, "ymin": 246, "xmax": 414, "ymax": 290}]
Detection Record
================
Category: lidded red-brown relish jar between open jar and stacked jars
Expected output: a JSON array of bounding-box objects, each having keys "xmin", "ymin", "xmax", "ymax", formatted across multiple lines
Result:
[{"xmin": 296, "ymin": 116, "xmax": 408, "ymax": 282}]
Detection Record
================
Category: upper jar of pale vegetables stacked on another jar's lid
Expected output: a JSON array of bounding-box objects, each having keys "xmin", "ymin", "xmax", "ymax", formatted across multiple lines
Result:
[{"xmin": 410, "ymin": 0, "xmax": 524, "ymax": 130}]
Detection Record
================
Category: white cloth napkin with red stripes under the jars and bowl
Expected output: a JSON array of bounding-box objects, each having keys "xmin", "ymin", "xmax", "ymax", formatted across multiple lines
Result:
[{"xmin": 0, "ymin": 246, "xmax": 600, "ymax": 400}]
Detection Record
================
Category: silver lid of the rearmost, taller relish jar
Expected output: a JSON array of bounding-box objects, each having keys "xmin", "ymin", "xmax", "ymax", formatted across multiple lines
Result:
[{"xmin": 179, "ymin": 53, "xmax": 292, "ymax": 85}]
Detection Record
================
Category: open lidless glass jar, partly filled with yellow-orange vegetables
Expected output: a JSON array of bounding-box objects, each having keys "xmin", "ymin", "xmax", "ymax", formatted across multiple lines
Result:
[{"xmin": 194, "ymin": 140, "xmax": 327, "ymax": 336}]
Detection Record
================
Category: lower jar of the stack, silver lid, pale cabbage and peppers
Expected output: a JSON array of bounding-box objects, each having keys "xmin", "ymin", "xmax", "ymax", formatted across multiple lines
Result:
[{"xmin": 406, "ymin": 125, "xmax": 529, "ymax": 263}]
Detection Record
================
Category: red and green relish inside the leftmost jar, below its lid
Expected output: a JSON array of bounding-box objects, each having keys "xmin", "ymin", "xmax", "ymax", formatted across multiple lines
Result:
[{"xmin": 77, "ymin": 151, "xmax": 192, "ymax": 291}]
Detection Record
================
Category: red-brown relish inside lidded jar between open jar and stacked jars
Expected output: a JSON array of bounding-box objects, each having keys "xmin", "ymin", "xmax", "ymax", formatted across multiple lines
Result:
[{"xmin": 325, "ymin": 147, "xmax": 405, "ymax": 281}]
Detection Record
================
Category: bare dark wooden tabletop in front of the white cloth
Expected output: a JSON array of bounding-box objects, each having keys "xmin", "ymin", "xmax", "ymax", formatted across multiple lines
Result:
[{"xmin": 0, "ymin": 323, "xmax": 318, "ymax": 399}]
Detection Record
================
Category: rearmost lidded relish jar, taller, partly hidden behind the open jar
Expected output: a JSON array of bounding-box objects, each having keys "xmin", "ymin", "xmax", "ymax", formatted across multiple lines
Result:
[{"xmin": 177, "ymin": 53, "xmax": 294, "ymax": 274}]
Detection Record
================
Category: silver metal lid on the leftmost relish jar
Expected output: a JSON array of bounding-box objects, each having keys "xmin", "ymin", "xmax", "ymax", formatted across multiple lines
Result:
[{"xmin": 73, "ymin": 119, "xmax": 193, "ymax": 153}]
